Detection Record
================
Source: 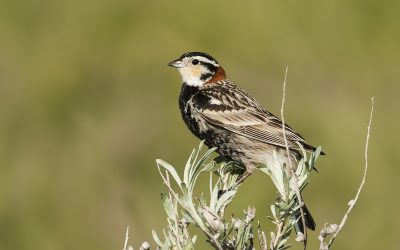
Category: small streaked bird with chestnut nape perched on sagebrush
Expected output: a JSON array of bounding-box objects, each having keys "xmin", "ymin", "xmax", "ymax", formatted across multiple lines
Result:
[{"xmin": 168, "ymin": 52, "xmax": 324, "ymax": 231}]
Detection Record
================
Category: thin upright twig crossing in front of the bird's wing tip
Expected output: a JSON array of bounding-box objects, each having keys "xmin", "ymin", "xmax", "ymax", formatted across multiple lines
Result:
[{"xmin": 281, "ymin": 66, "xmax": 307, "ymax": 249}]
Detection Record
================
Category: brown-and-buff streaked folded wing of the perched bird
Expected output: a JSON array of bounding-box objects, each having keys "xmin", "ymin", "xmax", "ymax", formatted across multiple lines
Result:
[{"xmin": 193, "ymin": 81, "xmax": 305, "ymax": 149}]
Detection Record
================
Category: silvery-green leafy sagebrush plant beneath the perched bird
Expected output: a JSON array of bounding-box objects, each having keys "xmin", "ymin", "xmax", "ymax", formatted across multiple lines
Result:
[{"xmin": 153, "ymin": 142, "xmax": 321, "ymax": 249}]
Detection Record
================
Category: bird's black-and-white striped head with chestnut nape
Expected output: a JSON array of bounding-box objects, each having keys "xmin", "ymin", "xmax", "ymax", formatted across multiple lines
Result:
[{"xmin": 168, "ymin": 52, "xmax": 226, "ymax": 87}]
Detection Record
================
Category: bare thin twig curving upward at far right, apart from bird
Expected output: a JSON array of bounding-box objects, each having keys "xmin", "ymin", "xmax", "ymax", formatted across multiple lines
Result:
[{"xmin": 328, "ymin": 97, "xmax": 374, "ymax": 248}]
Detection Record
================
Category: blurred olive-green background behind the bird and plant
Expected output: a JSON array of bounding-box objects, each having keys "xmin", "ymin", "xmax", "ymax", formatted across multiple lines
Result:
[{"xmin": 0, "ymin": 0, "xmax": 400, "ymax": 250}]
